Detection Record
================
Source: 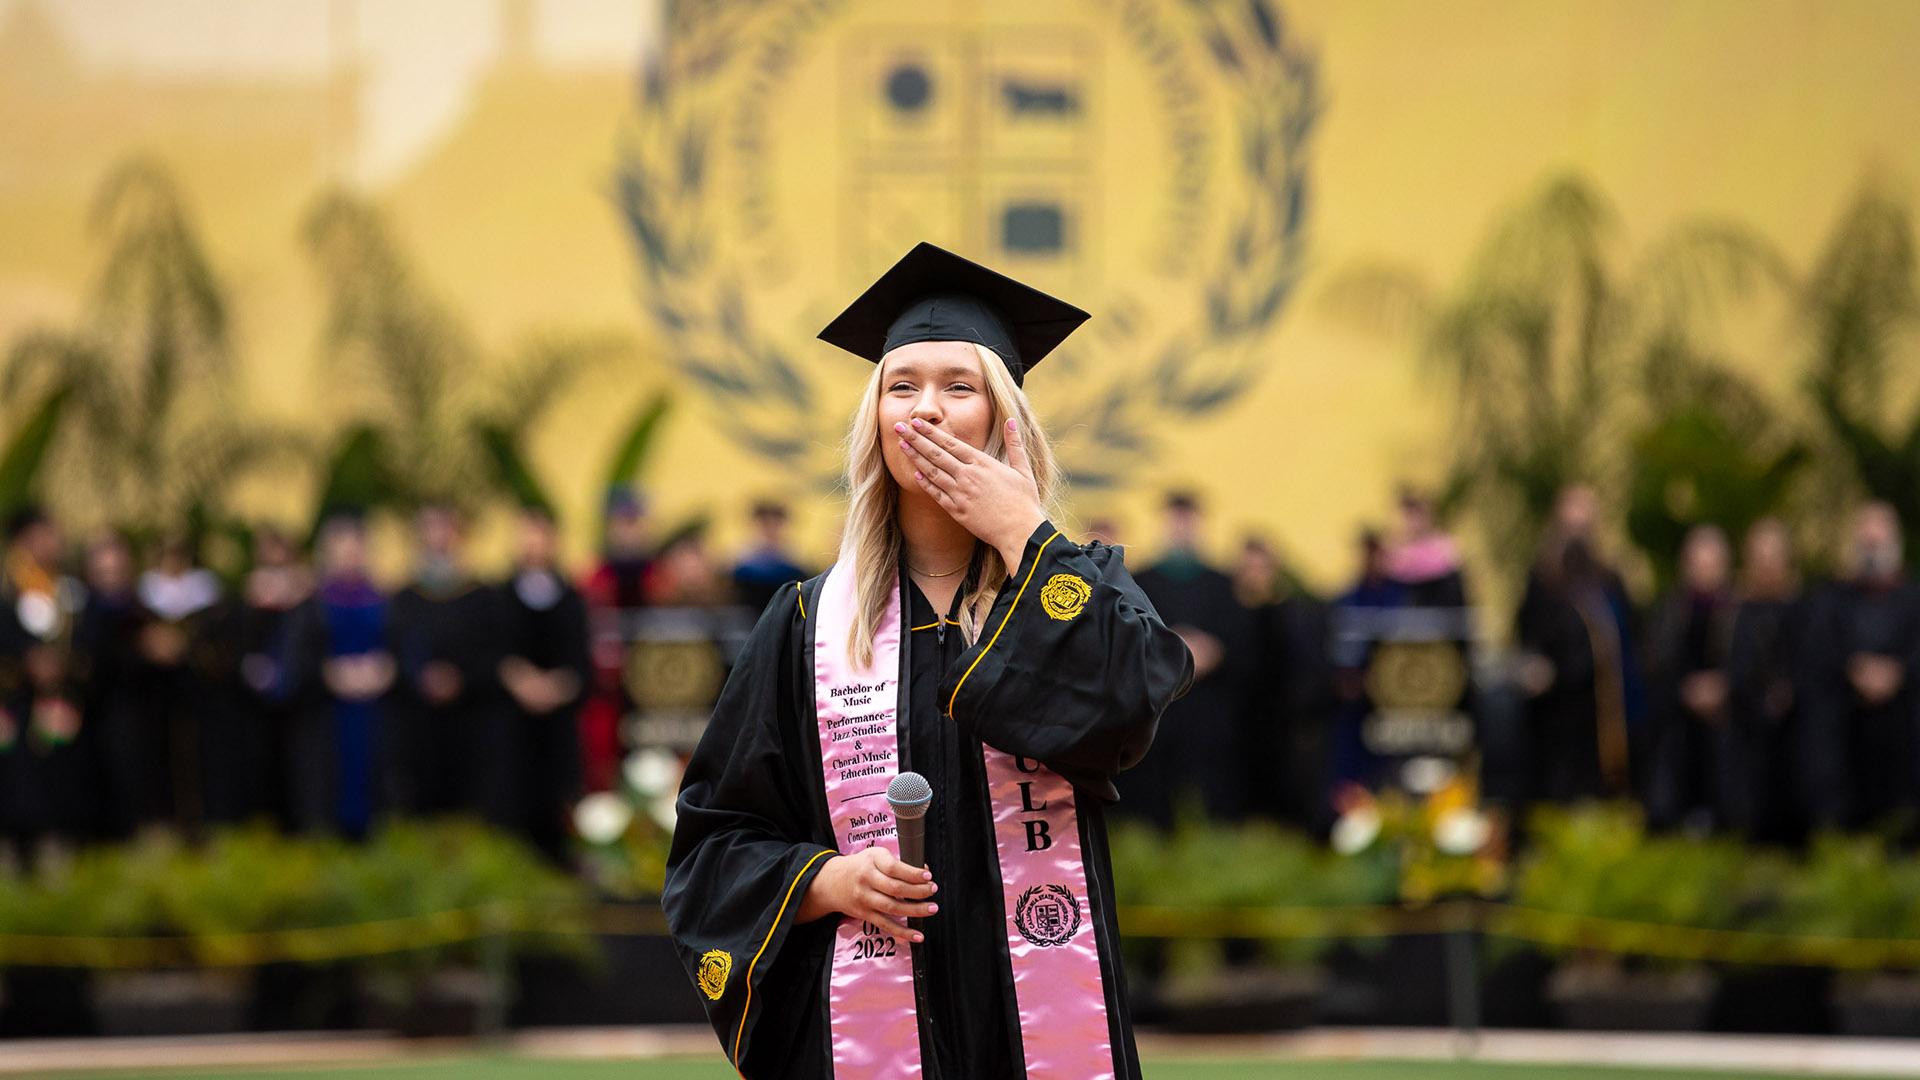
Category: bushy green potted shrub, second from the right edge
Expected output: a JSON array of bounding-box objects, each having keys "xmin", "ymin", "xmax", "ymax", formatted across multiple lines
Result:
[{"xmin": 1513, "ymin": 807, "xmax": 1780, "ymax": 1030}]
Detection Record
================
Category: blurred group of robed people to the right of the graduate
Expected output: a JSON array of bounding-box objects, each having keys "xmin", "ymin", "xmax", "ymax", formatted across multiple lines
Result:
[{"xmin": 1096, "ymin": 486, "xmax": 1920, "ymax": 844}]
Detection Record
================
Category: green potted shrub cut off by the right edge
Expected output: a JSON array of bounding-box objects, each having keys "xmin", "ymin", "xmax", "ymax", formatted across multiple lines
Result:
[{"xmin": 1766, "ymin": 836, "xmax": 1920, "ymax": 1036}]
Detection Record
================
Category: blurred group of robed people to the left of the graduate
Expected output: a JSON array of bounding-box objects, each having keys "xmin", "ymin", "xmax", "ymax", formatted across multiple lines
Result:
[{"xmin": 0, "ymin": 492, "xmax": 808, "ymax": 863}]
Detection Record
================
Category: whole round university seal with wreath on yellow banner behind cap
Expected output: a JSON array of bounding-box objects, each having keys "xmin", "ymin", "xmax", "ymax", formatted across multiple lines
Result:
[{"xmin": 614, "ymin": 0, "xmax": 1321, "ymax": 488}]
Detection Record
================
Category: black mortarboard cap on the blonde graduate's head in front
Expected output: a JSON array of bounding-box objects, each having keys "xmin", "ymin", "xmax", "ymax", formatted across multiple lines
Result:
[{"xmin": 820, "ymin": 242, "xmax": 1092, "ymax": 384}]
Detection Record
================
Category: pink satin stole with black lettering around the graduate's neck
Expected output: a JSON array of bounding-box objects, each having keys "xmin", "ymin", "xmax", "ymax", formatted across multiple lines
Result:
[{"xmin": 812, "ymin": 559, "xmax": 1116, "ymax": 1080}]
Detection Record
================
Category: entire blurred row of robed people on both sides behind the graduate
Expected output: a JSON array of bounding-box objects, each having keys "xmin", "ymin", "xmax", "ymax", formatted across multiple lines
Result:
[{"xmin": 0, "ymin": 476, "xmax": 1920, "ymax": 861}]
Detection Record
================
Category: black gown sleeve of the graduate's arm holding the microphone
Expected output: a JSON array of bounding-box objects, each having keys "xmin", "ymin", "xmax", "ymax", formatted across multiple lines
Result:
[{"xmin": 660, "ymin": 586, "xmax": 833, "ymax": 1076}]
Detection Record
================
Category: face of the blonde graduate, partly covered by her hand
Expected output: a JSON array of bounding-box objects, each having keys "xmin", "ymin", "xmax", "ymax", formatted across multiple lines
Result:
[{"xmin": 879, "ymin": 342, "xmax": 993, "ymax": 494}]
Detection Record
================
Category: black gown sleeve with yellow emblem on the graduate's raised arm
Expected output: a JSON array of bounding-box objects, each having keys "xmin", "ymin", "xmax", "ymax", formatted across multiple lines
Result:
[{"xmin": 939, "ymin": 523, "xmax": 1194, "ymax": 801}]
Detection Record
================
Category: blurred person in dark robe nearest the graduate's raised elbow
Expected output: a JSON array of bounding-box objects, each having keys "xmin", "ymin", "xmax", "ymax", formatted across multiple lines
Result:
[{"xmin": 1119, "ymin": 492, "xmax": 1252, "ymax": 828}]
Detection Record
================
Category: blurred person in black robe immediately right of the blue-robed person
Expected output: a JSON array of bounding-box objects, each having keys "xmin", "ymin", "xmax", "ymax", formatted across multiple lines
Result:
[{"xmin": 388, "ymin": 505, "xmax": 510, "ymax": 828}]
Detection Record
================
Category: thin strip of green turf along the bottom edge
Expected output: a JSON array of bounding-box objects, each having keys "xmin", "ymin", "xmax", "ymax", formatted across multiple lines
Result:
[{"xmin": 33, "ymin": 1057, "xmax": 1904, "ymax": 1080}]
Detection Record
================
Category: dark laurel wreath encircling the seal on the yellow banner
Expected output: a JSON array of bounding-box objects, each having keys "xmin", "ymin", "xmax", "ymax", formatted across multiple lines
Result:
[{"xmin": 614, "ymin": 0, "xmax": 1321, "ymax": 488}]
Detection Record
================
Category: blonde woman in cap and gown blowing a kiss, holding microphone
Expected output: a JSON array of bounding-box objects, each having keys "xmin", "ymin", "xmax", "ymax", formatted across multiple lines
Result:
[{"xmin": 662, "ymin": 244, "xmax": 1192, "ymax": 1080}]
